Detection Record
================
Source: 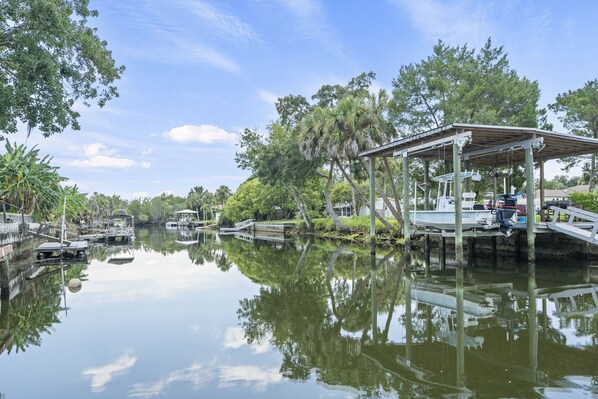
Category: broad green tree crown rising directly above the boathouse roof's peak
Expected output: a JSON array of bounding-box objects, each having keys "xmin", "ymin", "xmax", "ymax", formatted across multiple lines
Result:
[{"xmin": 389, "ymin": 39, "xmax": 547, "ymax": 135}]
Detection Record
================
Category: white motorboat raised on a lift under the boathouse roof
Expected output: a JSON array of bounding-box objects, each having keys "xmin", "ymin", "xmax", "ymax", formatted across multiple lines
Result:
[{"xmin": 409, "ymin": 172, "xmax": 516, "ymax": 233}]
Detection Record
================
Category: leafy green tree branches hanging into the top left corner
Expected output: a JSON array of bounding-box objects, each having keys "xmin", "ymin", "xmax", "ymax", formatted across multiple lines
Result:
[{"xmin": 0, "ymin": 0, "xmax": 124, "ymax": 137}]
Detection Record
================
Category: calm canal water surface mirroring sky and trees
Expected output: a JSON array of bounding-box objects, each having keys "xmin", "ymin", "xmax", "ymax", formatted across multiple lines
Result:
[{"xmin": 0, "ymin": 229, "xmax": 598, "ymax": 399}]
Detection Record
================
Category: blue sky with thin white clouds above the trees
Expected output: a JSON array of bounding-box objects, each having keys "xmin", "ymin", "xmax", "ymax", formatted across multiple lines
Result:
[{"xmin": 4, "ymin": 0, "xmax": 598, "ymax": 199}]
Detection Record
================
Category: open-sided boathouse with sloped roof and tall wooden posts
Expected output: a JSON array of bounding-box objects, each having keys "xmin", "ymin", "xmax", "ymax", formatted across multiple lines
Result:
[{"xmin": 360, "ymin": 123, "xmax": 598, "ymax": 264}]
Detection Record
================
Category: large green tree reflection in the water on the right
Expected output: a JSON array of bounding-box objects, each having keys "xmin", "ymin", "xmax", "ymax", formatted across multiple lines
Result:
[{"xmin": 223, "ymin": 236, "xmax": 598, "ymax": 397}]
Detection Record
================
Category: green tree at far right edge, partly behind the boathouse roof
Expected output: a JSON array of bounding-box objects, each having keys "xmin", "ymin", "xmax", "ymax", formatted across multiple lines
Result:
[{"xmin": 548, "ymin": 79, "xmax": 598, "ymax": 190}]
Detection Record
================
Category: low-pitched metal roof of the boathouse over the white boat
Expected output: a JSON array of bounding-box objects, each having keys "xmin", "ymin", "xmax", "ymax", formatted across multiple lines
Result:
[{"xmin": 359, "ymin": 123, "xmax": 598, "ymax": 166}]
